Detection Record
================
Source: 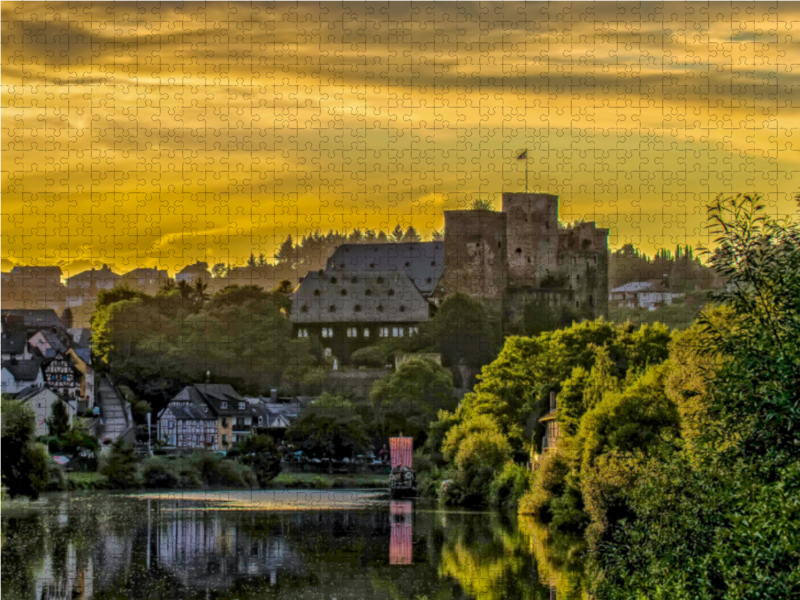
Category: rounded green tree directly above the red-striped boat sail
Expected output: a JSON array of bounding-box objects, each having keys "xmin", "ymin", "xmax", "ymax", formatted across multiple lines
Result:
[{"xmin": 370, "ymin": 357, "xmax": 456, "ymax": 444}]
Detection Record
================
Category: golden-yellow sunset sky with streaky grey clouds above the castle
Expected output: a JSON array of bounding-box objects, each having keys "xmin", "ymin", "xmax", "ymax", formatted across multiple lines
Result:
[{"xmin": 2, "ymin": 2, "xmax": 800, "ymax": 275}]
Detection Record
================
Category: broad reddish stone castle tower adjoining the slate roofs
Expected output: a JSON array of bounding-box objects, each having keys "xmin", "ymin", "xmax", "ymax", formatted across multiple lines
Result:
[{"xmin": 439, "ymin": 210, "xmax": 507, "ymax": 300}]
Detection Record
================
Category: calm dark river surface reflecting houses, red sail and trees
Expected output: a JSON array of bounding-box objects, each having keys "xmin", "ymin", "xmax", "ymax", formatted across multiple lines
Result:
[{"xmin": 2, "ymin": 490, "xmax": 584, "ymax": 600}]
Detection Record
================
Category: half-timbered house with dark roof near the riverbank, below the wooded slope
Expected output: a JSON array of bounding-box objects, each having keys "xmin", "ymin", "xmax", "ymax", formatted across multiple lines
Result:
[{"xmin": 158, "ymin": 384, "xmax": 252, "ymax": 450}]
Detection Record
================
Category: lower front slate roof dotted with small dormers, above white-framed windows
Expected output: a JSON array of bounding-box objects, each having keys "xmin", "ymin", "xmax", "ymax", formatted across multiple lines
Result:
[{"xmin": 291, "ymin": 270, "xmax": 430, "ymax": 324}]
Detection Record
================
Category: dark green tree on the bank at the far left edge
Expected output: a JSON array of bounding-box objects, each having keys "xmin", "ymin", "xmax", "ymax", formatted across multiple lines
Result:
[{"xmin": 0, "ymin": 397, "xmax": 50, "ymax": 499}]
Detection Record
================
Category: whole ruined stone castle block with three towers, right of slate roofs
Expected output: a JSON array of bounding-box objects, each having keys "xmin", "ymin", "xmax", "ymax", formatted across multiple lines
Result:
[{"xmin": 439, "ymin": 193, "xmax": 609, "ymax": 318}]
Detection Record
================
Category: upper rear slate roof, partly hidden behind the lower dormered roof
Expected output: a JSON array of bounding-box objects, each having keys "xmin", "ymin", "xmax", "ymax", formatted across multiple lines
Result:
[{"xmin": 326, "ymin": 242, "xmax": 444, "ymax": 296}]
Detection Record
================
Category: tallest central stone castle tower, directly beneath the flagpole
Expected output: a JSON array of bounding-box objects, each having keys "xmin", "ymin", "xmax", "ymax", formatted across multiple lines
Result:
[{"xmin": 503, "ymin": 193, "xmax": 558, "ymax": 287}]
